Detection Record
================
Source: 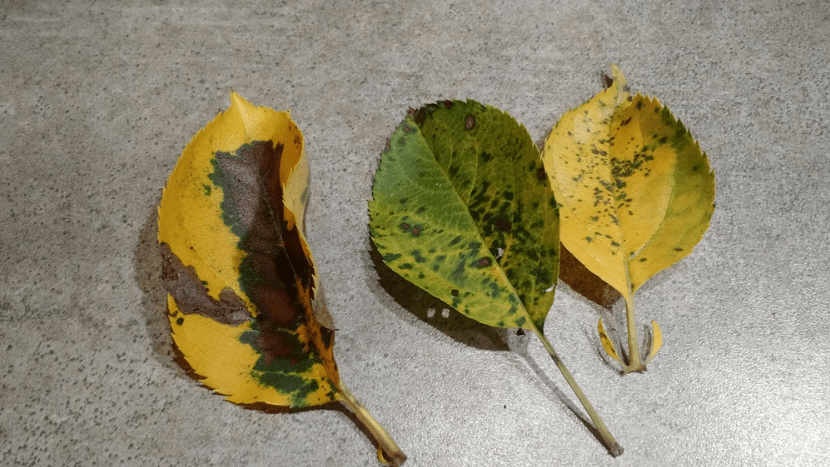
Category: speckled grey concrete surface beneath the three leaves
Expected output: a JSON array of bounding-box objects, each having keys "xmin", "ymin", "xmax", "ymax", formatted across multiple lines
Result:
[{"xmin": 0, "ymin": 0, "xmax": 830, "ymax": 467}]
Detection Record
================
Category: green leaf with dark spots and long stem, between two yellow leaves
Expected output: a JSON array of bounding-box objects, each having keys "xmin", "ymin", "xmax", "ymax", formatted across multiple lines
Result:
[{"xmin": 369, "ymin": 101, "xmax": 622, "ymax": 455}]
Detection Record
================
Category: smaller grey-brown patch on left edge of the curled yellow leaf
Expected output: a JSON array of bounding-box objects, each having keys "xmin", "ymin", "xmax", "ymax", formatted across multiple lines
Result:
[{"xmin": 161, "ymin": 243, "xmax": 252, "ymax": 326}]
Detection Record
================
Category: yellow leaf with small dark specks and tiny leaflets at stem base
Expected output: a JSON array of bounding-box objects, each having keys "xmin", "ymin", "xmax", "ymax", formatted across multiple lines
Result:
[{"xmin": 543, "ymin": 65, "xmax": 715, "ymax": 373}]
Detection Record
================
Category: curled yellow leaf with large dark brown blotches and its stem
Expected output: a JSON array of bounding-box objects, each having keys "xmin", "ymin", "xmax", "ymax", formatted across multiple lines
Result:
[{"xmin": 158, "ymin": 92, "xmax": 406, "ymax": 465}]
